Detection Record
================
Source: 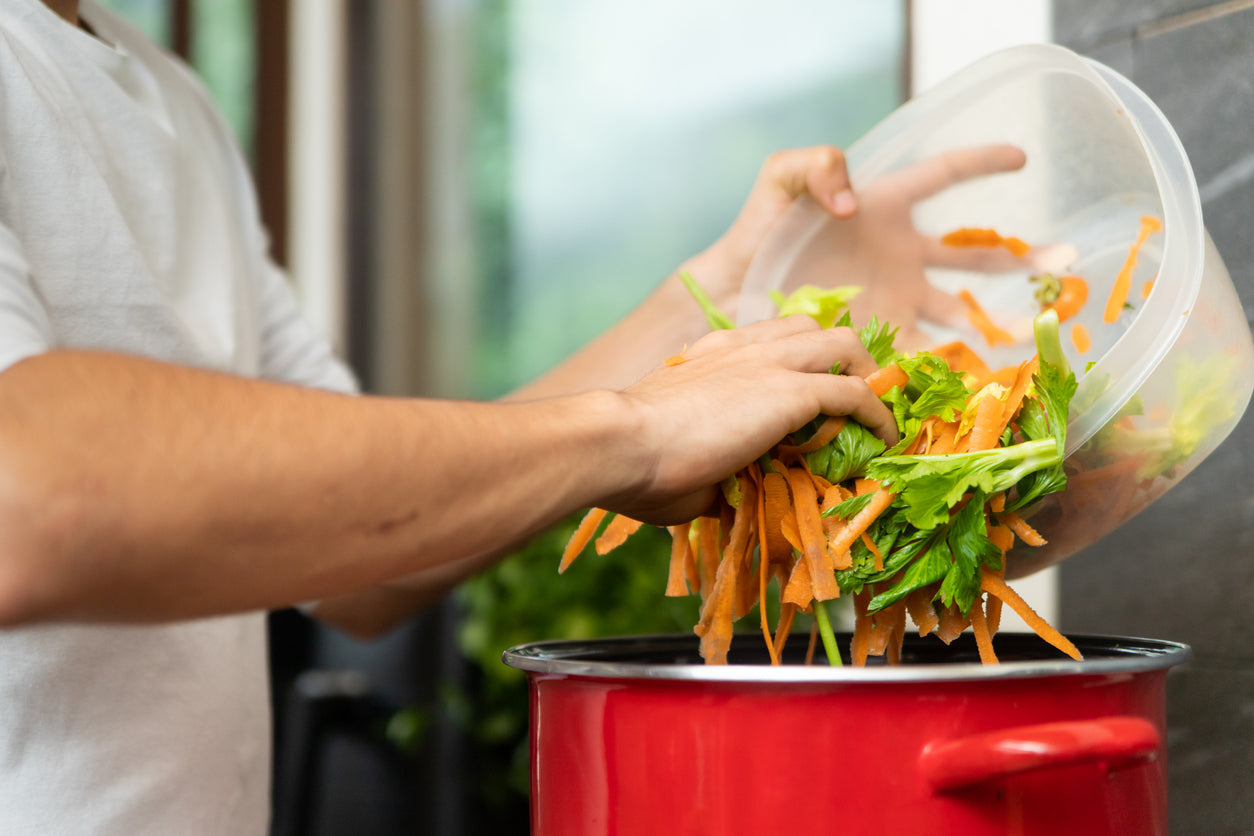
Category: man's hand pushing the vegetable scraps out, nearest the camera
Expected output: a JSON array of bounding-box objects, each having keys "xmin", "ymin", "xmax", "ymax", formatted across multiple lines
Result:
[{"xmin": 603, "ymin": 316, "xmax": 897, "ymax": 523}]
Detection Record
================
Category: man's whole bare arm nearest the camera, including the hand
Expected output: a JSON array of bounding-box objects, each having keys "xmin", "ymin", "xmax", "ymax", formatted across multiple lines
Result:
[{"xmin": 0, "ymin": 321, "xmax": 892, "ymax": 624}]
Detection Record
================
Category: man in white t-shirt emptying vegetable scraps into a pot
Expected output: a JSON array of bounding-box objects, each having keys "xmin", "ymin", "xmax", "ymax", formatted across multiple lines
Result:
[{"xmin": 0, "ymin": 0, "xmax": 1022, "ymax": 836}]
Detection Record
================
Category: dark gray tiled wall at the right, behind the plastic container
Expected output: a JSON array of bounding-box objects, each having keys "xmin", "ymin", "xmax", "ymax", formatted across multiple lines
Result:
[{"xmin": 1055, "ymin": 0, "xmax": 1254, "ymax": 836}]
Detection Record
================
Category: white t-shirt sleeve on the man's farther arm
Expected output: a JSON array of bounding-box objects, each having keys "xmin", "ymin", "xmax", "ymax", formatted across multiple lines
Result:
[{"xmin": 249, "ymin": 259, "xmax": 359, "ymax": 394}]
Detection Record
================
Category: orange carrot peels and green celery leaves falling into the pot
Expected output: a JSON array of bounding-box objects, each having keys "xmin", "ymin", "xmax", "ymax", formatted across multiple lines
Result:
[{"xmin": 559, "ymin": 277, "xmax": 1080, "ymax": 664}]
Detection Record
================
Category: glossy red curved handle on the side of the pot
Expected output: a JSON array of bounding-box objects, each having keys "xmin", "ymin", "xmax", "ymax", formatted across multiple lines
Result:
[{"xmin": 919, "ymin": 717, "xmax": 1162, "ymax": 793}]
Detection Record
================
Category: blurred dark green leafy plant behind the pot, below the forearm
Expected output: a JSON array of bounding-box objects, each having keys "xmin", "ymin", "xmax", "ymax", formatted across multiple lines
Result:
[{"xmin": 446, "ymin": 516, "xmax": 698, "ymax": 817}]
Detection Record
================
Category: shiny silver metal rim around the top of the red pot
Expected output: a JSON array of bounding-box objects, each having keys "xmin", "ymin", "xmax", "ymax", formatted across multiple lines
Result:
[{"xmin": 502, "ymin": 632, "xmax": 1193, "ymax": 684}]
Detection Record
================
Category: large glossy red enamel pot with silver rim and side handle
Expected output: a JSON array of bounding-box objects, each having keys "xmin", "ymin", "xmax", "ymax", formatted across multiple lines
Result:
[{"xmin": 504, "ymin": 633, "xmax": 1189, "ymax": 836}]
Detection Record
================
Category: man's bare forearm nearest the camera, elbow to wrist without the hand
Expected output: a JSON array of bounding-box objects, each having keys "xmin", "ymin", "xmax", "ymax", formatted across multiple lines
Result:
[{"xmin": 0, "ymin": 352, "xmax": 647, "ymax": 623}]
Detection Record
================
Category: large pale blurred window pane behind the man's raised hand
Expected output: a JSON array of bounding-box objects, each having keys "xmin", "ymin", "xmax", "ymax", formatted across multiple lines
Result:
[{"xmin": 466, "ymin": 0, "xmax": 905, "ymax": 396}]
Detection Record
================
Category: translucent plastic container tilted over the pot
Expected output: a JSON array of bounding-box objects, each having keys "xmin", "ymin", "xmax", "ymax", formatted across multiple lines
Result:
[{"xmin": 739, "ymin": 45, "xmax": 1254, "ymax": 577}]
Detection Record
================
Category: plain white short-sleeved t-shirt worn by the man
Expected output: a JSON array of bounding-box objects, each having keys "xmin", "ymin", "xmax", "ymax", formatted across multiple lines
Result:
[{"xmin": 0, "ymin": 0, "xmax": 354, "ymax": 836}]
